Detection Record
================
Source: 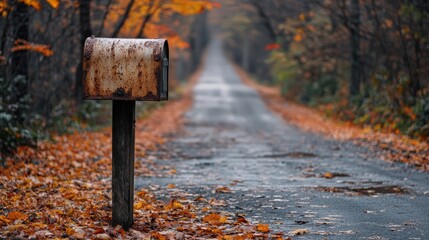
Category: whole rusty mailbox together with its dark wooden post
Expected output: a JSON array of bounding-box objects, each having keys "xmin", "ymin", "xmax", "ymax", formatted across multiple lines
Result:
[{"xmin": 83, "ymin": 37, "xmax": 168, "ymax": 229}]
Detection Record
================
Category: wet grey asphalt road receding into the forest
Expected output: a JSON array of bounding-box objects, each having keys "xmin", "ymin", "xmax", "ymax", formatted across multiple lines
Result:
[{"xmin": 136, "ymin": 41, "xmax": 429, "ymax": 239}]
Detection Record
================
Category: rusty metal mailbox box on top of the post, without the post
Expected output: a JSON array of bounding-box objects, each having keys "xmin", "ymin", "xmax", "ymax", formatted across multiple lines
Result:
[{"xmin": 83, "ymin": 37, "xmax": 169, "ymax": 101}]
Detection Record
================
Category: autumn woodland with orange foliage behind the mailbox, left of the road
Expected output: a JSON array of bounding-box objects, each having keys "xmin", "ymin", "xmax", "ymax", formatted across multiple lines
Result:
[{"xmin": 0, "ymin": 0, "xmax": 214, "ymax": 162}]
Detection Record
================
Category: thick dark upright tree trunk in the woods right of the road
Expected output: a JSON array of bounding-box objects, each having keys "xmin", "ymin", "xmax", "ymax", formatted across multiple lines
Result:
[{"xmin": 349, "ymin": 0, "xmax": 362, "ymax": 98}]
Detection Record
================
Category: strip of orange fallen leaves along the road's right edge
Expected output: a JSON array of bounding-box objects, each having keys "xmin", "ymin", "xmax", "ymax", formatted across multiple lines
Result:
[{"xmin": 235, "ymin": 67, "xmax": 429, "ymax": 171}]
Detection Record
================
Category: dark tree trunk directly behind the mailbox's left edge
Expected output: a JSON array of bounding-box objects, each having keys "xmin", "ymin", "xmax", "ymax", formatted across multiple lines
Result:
[{"xmin": 74, "ymin": 0, "xmax": 92, "ymax": 107}]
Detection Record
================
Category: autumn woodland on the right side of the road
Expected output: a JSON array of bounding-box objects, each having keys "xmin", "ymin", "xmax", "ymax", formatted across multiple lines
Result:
[{"xmin": 221, "ymin": 0, "xmax": 429, "ymax": 140}]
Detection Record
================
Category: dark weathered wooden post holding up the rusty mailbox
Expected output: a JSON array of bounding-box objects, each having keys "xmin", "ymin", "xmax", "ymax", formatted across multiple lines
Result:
[{"xmin": 112, "ymin": 100, "xmax": 135, "ymax": 229}]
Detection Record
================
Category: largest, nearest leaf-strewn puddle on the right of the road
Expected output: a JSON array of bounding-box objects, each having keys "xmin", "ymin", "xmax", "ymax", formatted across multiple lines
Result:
[{"xmin": 313, "ymin": 185, "xmax": 411, "ymax": 196}]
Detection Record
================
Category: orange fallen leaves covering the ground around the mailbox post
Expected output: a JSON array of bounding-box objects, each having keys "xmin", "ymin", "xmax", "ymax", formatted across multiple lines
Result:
[{"xmin": 0, "ymin": 70, "xmax": 290, "ymax": 239}]
